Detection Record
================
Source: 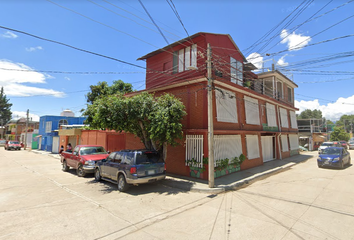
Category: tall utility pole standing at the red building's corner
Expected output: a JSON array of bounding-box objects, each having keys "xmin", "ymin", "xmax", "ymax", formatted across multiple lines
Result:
[{"xmin": 207, "ymin": 43, "xmax": 214, "ymax": 188}]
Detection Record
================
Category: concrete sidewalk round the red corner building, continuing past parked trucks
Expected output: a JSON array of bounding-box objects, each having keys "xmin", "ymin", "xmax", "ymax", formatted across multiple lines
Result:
[{"xmin": 30, "ymin": 150, "xmax": 318, "ymax": 194}]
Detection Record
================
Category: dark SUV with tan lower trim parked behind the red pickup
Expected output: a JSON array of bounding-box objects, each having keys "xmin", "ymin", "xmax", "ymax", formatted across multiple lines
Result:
[{"xmin": 95, "ymin": 150, "xmax": 166, "ymax": 192}]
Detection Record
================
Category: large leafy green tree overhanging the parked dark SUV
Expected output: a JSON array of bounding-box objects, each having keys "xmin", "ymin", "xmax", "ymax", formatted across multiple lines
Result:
[{"xmin": 83, "ymin": 92, "xmax": 186, "ymax": 159}]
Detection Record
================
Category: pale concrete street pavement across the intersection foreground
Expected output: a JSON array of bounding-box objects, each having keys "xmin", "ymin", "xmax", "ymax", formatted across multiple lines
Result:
[{"xmin": 0, "ymin": 148, "xmax": 354, "ymax": 240}]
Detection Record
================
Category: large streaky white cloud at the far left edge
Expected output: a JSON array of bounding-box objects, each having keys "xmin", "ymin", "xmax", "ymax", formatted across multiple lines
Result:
[{"xmin": 0, "ymin": 60, "xmax": 65, "ymax": 98}]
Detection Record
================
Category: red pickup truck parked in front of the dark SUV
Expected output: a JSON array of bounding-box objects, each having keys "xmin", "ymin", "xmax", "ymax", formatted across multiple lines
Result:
[{"xmin": 60, "ymin": 145, "xmax": 109, "ymax": 177}]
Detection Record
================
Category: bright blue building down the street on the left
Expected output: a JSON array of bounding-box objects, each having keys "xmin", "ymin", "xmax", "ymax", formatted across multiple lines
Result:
[{"xmin": 37, "ymin": 114, "xmax": 86, "ymax": 153}]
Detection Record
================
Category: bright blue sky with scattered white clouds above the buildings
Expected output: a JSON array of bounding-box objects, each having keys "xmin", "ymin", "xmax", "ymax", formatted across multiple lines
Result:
[{"xmin": 0, "ymin": 0, "xmax": 354, "ymax": 121}]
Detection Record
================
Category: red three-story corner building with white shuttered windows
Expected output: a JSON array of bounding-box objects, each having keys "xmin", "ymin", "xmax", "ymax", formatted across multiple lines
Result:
[{"xmin": 133, "ymin": 32, "xmax": 298, "ymax": 179}]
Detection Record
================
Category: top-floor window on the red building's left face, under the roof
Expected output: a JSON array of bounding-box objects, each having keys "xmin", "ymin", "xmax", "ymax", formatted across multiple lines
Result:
[{"xmin": 173, "ymin": 44, "xmax": 197, "ymax": 73}]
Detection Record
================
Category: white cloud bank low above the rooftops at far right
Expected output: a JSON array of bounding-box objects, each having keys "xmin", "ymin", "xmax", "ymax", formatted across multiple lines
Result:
[{"xmin": 295, "ymin": 95, "xmax": 354, "ymax": 121}]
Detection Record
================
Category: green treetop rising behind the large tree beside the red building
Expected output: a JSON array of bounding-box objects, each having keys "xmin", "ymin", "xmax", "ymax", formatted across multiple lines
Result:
[{"xmin": 86, "ymin": 80, "xmax": 133, "ymax": 104}]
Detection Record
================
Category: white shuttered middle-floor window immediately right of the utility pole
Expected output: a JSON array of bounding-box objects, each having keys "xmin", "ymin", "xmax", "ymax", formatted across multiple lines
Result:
[{"xmin": 215, "ymin": 89, "xmax": 238, "ymax": 123}]
